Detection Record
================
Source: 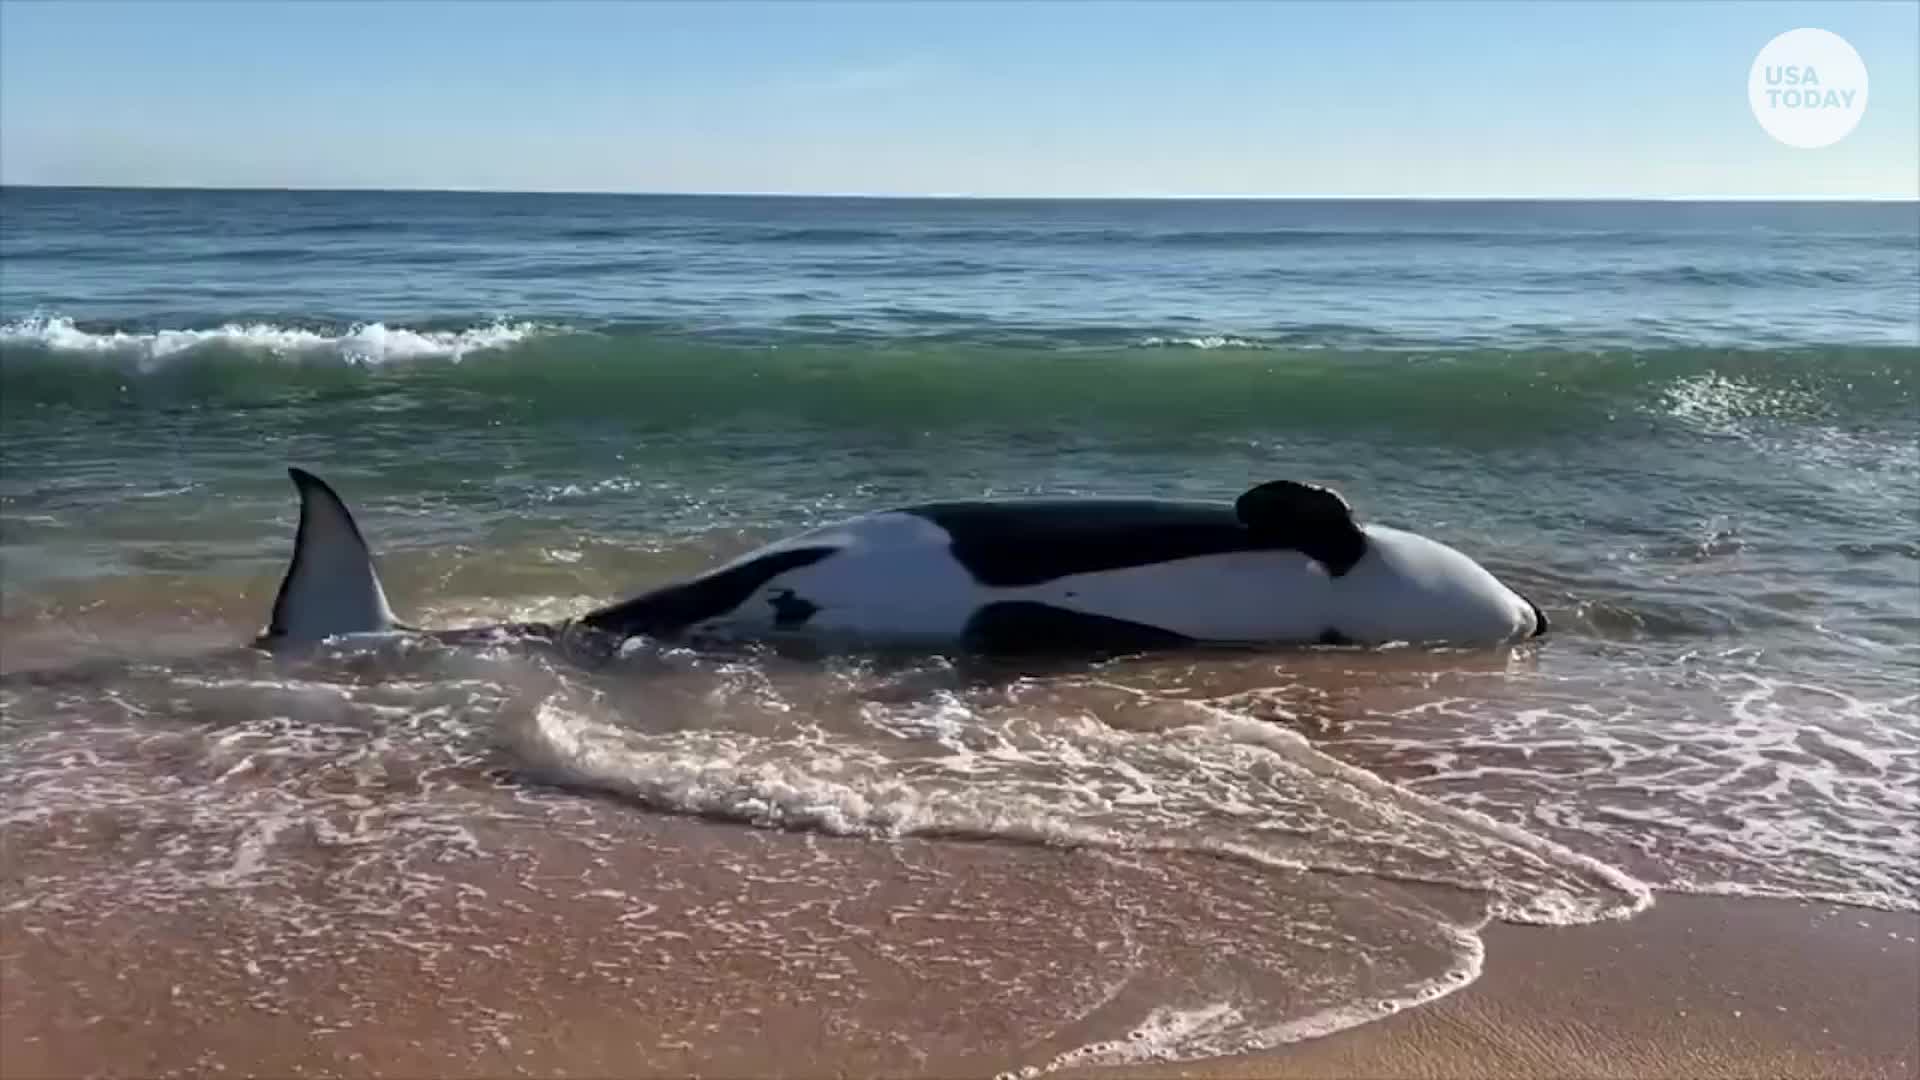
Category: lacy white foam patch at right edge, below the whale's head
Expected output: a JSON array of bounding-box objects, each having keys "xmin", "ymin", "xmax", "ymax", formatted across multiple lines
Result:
[{"xmin": 1346, "ymin": 657, "xmax": 1920, "ymax": 911}]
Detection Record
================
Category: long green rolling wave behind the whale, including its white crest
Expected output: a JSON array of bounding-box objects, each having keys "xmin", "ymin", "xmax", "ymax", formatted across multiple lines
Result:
[{"xmin": 0, "ymin": 311, "xmax": 1920, "ymax": 442}]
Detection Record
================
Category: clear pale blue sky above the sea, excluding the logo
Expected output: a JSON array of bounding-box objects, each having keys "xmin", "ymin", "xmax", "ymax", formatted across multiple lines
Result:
[{"xmin": 0, "ymin": 0, "xmax": 1920, "ymax": 198}]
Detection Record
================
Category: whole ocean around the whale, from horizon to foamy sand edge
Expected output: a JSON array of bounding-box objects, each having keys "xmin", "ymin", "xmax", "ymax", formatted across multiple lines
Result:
[{"xmin": 0, "ymin": 188, "xmax": 1920, "ymax": 1074}]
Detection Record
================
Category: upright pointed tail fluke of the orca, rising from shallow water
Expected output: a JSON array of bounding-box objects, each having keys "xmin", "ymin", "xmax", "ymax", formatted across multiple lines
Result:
[{"xmin": 267, "ymin": 469, "xmax": 397, "ymax": 642}]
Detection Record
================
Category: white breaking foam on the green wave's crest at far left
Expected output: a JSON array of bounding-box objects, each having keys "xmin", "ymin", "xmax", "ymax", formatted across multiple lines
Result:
[{"xmin": 0, "ymin": 315, "xmax": 555, "ymax": 363}]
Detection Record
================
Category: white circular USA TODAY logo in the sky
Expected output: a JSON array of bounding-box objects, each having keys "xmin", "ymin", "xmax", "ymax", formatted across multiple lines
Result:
[{"xmin": 1747, "ymin": 27, "xmax": 1866, "ymax": 150}]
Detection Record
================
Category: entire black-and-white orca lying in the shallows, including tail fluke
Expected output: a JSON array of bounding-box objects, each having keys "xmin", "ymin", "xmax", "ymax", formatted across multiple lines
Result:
[{"xmin": 261, "ymin": 461, "xmax": 1548, "ymax": 653}]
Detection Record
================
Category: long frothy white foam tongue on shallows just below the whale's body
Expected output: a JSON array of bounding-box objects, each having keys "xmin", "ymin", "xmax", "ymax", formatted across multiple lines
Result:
[{"xmin": 501, "ymin": 690, "xmax": 1651, "ymax": 924}]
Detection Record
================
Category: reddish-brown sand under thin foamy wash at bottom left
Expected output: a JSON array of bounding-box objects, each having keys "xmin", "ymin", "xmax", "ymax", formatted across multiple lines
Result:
[{"xmin": 0, "ymin": 788, "xmax": 1473, "ymax": 1080}]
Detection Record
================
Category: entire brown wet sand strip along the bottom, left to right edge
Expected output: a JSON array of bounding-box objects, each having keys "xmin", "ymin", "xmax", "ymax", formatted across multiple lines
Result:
[{"xmin": 0, "ymin": 780, "xmax": 1920, "ymax": 1078}]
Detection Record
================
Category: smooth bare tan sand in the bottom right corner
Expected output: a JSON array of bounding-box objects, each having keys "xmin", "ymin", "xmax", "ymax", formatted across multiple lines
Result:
[{"xmin": 1105, "ymin": 896, "xmax": 1920, "ymax": 1080}]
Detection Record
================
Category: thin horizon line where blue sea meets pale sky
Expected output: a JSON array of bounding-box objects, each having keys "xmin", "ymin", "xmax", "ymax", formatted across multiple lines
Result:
[{"xmin": 0, "ymin": 183, "xmax": 1920, "ymax": 204}]
